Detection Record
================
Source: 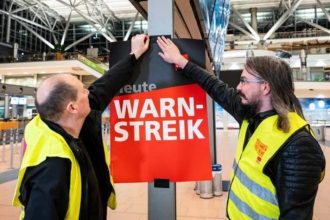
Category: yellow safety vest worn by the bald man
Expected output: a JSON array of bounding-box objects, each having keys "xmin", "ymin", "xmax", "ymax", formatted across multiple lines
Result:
[{"xmin": 13, "ymin": 115, "xmax": 116, "ymax": 220}]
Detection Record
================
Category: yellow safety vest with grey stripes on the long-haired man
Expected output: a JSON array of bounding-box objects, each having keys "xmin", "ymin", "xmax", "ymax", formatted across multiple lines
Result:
[{"xmin": 227, "ymin": 113, "xmax": 307, "ymax": 220}]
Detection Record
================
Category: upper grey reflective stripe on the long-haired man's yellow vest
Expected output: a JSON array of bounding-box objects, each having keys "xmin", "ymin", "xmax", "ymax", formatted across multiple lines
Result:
[{"xmin": 234, "ymin": 161, "xmax": 278, "ymax": 206}]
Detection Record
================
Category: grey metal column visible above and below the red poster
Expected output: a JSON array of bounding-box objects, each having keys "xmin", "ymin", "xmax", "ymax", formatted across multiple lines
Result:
[{"xmin": 148, "ymin": 0, "xmax": 176, "ymax": 220}]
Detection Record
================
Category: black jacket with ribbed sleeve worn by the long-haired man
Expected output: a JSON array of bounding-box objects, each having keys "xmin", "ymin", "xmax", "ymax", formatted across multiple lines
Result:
[{"xmin": 183, "ymin": 62, "xmax": 325, "ymax": 220}]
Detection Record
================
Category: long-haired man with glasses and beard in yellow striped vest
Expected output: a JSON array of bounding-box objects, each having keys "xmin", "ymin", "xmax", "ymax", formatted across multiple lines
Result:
[{"xmin": 157, "ymin": 37, "xmax": 325, "ymax": 220}]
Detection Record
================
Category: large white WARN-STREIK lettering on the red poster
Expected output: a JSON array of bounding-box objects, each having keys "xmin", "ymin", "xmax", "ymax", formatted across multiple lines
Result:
[{"xmin": 114, "ymin": 97, "xmax": 205, "ymax": 142}]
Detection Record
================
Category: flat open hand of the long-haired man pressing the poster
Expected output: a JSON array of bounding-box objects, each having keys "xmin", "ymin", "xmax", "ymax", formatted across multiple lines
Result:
[{"xmin": 157, "ymin": 36, "xmax": 188, "ymax": 69}]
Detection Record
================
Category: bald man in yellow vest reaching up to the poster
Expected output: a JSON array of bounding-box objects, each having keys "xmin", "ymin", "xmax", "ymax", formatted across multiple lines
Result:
[{"xmin": 13, "ymin": 34, "xmax": 149, "ymax": 220}]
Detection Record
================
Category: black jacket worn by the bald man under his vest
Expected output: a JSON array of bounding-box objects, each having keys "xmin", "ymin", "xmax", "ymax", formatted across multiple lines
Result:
[{"xmin": 20, "ymin": 55, "xmax": 136, "ymax": 220}]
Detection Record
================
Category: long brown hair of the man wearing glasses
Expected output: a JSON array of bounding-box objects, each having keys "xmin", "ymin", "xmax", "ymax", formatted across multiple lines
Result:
[{"xmin": 245, "ymin": 56, "xmax": 304, "ymax": 132}]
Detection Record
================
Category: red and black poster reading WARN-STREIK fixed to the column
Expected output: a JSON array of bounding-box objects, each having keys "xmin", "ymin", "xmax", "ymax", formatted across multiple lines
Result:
[{"xmin": 110, "ymin": 37, "xmax": 212, "ymax": 183}]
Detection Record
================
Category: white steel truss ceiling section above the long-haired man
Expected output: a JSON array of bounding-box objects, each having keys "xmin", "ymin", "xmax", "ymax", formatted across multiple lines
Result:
[{"xmin": 227, "ymin": 0, "xmax": 330, "ymax": 50}]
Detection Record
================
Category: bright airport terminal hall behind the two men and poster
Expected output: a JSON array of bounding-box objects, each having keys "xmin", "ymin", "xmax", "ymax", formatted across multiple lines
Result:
[{"xmin": 0, "ymin": 0, "xmax": 330, "ymax": 220}]
